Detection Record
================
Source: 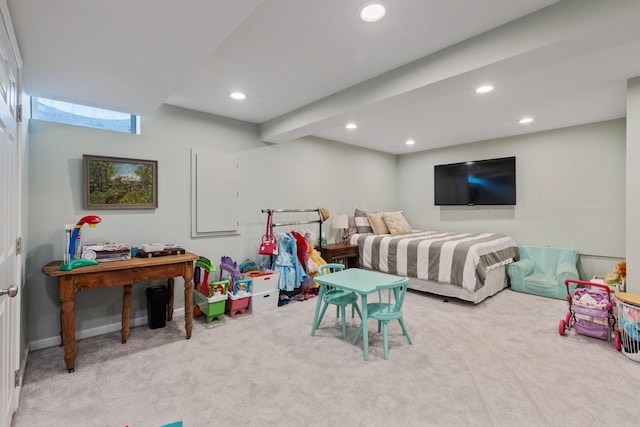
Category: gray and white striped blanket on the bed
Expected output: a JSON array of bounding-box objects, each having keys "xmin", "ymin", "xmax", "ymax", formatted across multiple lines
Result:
[{"xmin": 349, "ymin": 231, "xmax": 518, "ymax": 292}]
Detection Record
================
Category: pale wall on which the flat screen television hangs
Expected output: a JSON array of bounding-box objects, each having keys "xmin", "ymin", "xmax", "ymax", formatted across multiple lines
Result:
[{"xmin": 398, "ymin": 119, "xmax": 627, "ymax": 279}]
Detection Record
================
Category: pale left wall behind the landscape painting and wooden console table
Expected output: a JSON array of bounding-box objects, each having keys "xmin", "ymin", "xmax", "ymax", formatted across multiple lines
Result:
[{"xmin": 26, "ymin": 106, "xmax": 397, "ymax": 349}]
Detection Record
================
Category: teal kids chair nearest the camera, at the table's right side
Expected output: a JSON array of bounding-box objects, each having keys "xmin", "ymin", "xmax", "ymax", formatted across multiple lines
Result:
[{"xmin": 353, "ymin": 277, "xmax": 413, "ymax": 360}]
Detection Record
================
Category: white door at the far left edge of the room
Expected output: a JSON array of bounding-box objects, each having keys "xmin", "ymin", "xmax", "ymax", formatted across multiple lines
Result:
[{"xmin": 0, "ymin": 1, "xmax": 20, "ymax": 426}]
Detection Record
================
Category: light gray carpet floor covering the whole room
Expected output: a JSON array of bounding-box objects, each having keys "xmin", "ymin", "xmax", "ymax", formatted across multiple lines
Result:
[{"xmin": 12, "ymin": 289, "xmax": 640, "ymax": 427}]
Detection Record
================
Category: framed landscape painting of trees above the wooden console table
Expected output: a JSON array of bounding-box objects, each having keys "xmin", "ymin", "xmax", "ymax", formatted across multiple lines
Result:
[{"xmin": 82, "ymin": 154, "xmax": 158, "ymax": 209}]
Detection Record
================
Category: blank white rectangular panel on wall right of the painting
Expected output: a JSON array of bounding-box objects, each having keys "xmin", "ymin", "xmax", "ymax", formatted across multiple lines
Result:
[{"xmin": 191, "ymin": 150, "xmax": 239, "ymax": 237}]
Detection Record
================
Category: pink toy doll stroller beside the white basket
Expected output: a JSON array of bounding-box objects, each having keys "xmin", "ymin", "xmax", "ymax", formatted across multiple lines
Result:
[{"xmin": 558, "ymin": 279, "xmax": 622, "ymax": 351}]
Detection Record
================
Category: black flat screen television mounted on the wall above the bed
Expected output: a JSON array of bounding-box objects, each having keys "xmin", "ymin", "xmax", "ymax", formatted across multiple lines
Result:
[{"xmin": 433, "ymin": 157, "xmax": 516, "ymax": 206}]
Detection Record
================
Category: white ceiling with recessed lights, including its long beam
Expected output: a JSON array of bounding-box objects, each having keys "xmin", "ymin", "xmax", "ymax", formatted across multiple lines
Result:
[{"xmin": 7, "ymin": 0, "xmax": 640, "ymax": 154}]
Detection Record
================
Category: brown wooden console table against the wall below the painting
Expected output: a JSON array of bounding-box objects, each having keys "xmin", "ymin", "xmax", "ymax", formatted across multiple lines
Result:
[{"xmin": 42, "ymin": 252, "xmax": 198, "ymax": 372}]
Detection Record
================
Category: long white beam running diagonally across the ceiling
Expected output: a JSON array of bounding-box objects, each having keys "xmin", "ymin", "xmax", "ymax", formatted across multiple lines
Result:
[{"xmin": 259, "ymin": 0, "xmax": 640, "ymax": 143}]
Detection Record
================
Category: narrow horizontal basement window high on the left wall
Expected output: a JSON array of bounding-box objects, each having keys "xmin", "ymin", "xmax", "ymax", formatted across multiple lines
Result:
[{"xmin": 31, "ymin": 96, "xmax": 140, "ymax": 134}]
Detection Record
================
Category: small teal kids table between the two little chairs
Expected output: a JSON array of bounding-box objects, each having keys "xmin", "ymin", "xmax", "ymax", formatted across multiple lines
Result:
[{"xmin": 311, "ymin": 268, "xmax": 409, "ymax": 360}]
